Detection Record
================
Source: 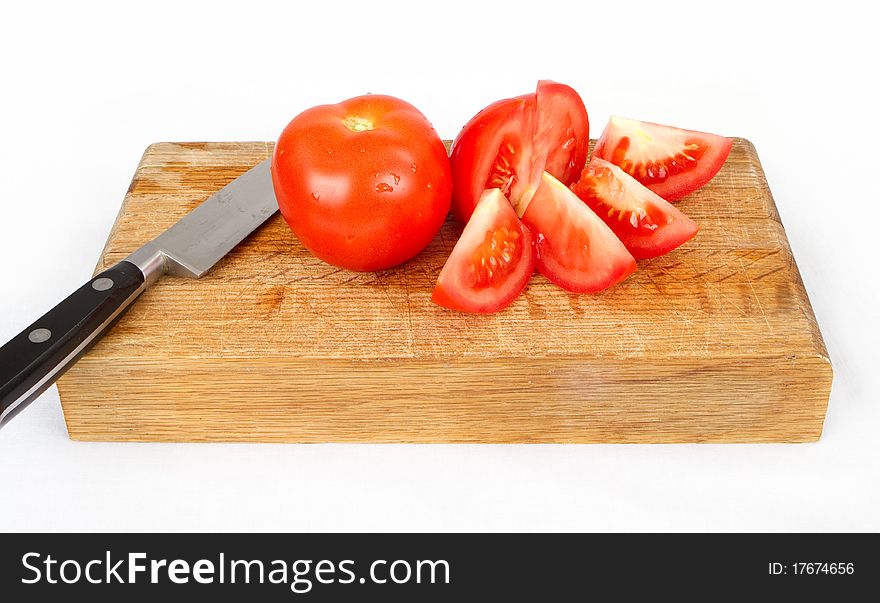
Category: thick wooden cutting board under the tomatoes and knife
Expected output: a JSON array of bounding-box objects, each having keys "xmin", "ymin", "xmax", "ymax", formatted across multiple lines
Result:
[{"xmin": 59, "ymin": 139, "xmax": 831, "ymax": 442}]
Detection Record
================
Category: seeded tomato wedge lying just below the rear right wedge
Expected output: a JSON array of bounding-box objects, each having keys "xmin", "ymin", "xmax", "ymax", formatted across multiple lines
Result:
[{"xmin": 571, "ymin": 157, "xmax": 700, "ymax": 260}]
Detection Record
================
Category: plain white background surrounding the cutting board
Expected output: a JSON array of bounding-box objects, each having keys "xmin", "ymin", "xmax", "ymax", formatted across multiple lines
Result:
[{"xmin": 0, "ymin": 0, "xmax": 880, "ymax": 531}]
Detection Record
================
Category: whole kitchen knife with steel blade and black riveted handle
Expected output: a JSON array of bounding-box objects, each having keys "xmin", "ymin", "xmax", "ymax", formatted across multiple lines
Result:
[{"xmin": 0, "ymin": 159, "xmax": 278, "ymax": 427}]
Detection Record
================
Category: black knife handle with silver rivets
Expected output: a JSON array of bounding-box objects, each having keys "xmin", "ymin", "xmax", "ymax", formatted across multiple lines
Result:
[{"xmin": 0, "ymin": 261, "xmax": 145, "ymax": 427}]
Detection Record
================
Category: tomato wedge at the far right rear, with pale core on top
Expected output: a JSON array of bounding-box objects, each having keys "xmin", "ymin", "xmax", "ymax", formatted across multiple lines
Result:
[{"xmin": 593, "ymin": 116, "xmax": 732, "ymax": 201}]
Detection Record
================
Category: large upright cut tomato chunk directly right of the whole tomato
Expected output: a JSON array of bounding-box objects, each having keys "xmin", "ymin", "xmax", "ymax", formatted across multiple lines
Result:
[{"xmin": 450, "ymin": 81, "xmax": 590, "ymax": 223}]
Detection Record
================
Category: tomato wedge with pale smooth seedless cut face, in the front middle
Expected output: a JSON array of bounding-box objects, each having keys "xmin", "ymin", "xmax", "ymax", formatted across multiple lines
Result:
[{"xmin": 522, "ymin": 172, "xmax": 636, "ymax": 293}]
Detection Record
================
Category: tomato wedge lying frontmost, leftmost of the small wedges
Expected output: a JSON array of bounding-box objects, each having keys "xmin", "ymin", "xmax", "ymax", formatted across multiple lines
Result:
[{"xmin": 431, "ymin": 188, "xmax": 536, "ymax": 314}]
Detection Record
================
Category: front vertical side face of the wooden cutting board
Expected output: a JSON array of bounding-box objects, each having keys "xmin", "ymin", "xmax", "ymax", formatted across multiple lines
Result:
[{"xmin": 60, "ymin": 357, "xmax": 832, "ymax": 443}]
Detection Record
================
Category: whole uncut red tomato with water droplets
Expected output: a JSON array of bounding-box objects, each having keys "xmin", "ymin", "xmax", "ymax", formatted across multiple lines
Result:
[{"xmin": 272, "ymin": 95, "xmax": 452, "ymax": 271}]
